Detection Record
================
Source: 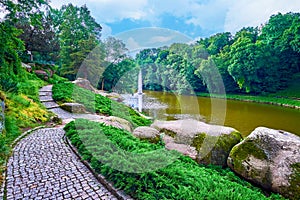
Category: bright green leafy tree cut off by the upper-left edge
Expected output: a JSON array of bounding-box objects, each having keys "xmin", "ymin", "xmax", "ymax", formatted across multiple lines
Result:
[{"xmin": 0, "ymin": 0, "xmax": 47, "ymax": 77}]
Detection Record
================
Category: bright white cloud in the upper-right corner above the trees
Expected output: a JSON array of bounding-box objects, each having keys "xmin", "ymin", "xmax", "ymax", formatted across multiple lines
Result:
[{"xmin": 224, "ymin": 0, "xmax": 300, "ymax": 33}]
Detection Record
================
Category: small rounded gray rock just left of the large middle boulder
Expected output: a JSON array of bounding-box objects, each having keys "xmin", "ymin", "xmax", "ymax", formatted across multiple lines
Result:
[{"xmin": 133, "ymin": 126, "xmax": 160, "ymax": 143}]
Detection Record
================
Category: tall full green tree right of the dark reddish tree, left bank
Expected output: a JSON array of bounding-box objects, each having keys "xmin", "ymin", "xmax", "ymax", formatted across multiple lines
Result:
[{"xmin": 55, "ymin": 4, "xmax": 102, "ymax": 80}]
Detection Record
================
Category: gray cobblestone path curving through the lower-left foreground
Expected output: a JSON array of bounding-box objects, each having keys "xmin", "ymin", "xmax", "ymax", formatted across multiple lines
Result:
[{"xmin": 7, "ymin": 128, "xmax": 116, "ymax": 200}]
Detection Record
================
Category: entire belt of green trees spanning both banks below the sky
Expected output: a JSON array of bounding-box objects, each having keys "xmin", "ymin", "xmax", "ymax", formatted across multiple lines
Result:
[{"xmin": 0, "ymin": 0, "xmax": 300, "ymax": 94}]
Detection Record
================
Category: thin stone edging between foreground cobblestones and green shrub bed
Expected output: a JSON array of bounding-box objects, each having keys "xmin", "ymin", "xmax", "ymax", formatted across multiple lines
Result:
[{"xmin": 63, "ymin": 135, "xmax": 133, "ymax": 200}]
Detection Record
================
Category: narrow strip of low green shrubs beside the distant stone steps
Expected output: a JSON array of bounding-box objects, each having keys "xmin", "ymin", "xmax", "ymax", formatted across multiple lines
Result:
[{"xmin": 52, "ymin": 82, "xmax": 151, "ymax": 127}]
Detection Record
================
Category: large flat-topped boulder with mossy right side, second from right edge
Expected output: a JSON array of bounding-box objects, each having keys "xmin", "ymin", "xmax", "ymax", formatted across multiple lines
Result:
[{"xmin": 151, "ymin": 119, "xmax": 242, "ymax": 167}]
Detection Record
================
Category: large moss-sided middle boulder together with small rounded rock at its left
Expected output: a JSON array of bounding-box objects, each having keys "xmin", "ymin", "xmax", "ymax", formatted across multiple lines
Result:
[{"xmin": 134, "ymin": 119, "xmax": 242, "ymax": 166}]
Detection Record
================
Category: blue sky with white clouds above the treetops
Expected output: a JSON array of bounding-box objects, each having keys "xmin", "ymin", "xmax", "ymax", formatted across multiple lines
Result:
[{"xmin": 51, "ymin": 0, "xmax": 300, "ymax": 47}]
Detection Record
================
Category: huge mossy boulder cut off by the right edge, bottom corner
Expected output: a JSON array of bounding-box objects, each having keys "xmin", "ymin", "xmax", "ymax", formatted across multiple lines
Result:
[{"xmin": 228, "ymin": 127, "xmax": 300, "ymax": 199}]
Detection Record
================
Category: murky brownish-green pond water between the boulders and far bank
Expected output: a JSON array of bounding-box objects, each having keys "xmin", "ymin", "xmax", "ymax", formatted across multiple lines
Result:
[{"xmin": 145, "ymin": 91, "xmax": 300, "ymax": 136}]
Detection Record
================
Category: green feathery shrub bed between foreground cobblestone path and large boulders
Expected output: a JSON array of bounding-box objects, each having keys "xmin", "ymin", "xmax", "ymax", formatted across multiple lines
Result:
[{"xmin": 65, "ymin": 119, "xmax": 282, "ymax": 200}]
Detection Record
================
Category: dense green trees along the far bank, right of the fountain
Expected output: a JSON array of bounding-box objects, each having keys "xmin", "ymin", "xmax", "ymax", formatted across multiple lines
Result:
[{"xmin": 123, "ymin": 13, "xmax": 300, "ymax": 94}]
